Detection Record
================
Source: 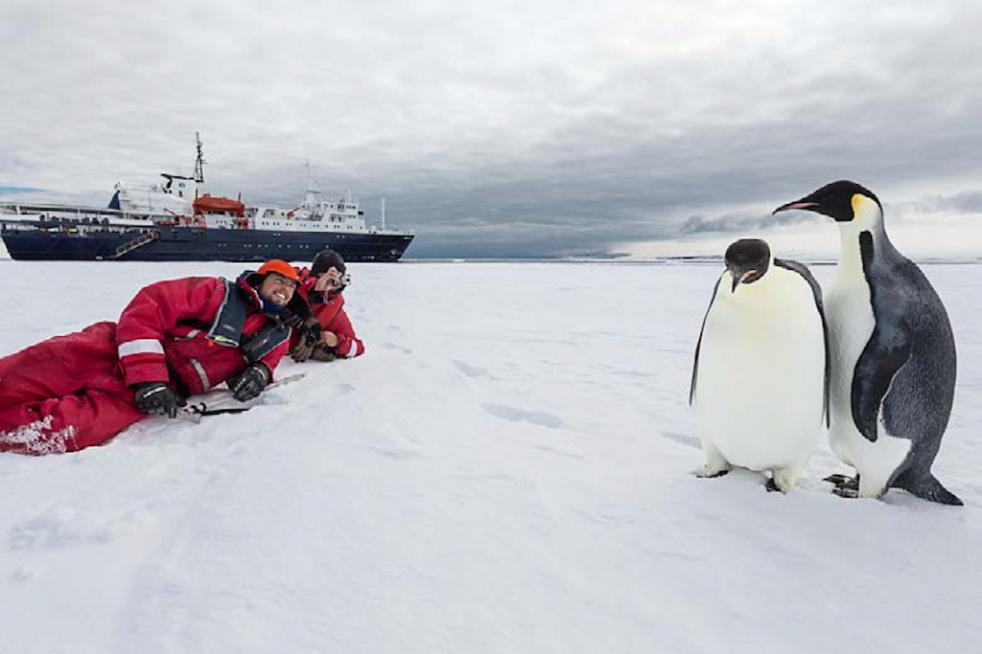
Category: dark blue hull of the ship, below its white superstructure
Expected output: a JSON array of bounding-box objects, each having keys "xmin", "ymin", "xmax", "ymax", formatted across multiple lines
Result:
[{"xmin": 0, "ymin": 223, "xmax": 413, "ymax": 261}]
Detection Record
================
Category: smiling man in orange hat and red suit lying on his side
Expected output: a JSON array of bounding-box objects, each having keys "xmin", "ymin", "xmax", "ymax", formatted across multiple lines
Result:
[{"xmin": 0, "ymin": 259, "xmax": 310, "ymax": 454}]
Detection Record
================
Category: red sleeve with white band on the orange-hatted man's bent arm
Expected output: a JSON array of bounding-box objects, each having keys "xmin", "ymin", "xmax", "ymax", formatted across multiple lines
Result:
[{"xmin": 116, "ymin": 277, "xmax": 225, "ymax": 385}]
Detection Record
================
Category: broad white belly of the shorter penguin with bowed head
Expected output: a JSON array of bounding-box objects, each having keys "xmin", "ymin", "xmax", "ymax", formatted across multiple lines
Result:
[{"xmin": 696, "ymin": 269, "xmax": 825, "ymax": 470}]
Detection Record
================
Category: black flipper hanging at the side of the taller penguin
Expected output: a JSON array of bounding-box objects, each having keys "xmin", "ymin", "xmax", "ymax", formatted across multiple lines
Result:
[{"xmin": 852, "ymin": 322, "xmax": 911, "ymax": 443}]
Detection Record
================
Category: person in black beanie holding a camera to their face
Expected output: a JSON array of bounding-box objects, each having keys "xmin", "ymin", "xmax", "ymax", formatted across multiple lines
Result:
[{"xmin": 290, "ymin": 250, "xmax": 365, "ymax": 361}]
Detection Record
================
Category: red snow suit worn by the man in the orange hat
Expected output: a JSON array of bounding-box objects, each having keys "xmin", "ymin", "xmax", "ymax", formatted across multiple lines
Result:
[{"xmin": 0, "ymin": 276, "xmax": 289, "ymax": 454}]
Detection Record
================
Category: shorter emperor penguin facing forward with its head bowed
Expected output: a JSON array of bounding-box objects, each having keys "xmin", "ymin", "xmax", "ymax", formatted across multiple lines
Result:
[{"xmin": 689, "ymin": 239, "xmax": 828, "ymax": 493}]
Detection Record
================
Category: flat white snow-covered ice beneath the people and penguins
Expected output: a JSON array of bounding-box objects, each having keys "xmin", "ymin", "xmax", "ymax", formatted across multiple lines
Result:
[{"xmin": 0, "ymin": 260, "xmax": 982, "ymax": 654}]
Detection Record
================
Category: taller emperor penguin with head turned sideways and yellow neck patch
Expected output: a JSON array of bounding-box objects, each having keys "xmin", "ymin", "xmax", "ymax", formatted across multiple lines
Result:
[{"xmin": 774, "ymin": 181, "xmax": 962, "ymax": 504}]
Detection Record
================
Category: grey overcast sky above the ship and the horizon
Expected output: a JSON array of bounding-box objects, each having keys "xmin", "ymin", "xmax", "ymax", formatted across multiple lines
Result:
[{"xmin": 0, "ymin": 0, "xmax": 982, "ymax": 257}]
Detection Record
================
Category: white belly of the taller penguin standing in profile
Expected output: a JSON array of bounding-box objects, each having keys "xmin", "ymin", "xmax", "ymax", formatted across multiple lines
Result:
[{"xmin": 825, "ymin": 273, "xmax": 910, "ymax": 487}]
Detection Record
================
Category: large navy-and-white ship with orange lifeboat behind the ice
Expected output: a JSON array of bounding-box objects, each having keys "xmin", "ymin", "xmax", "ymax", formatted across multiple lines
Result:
[{"xmin": 0, "ymin": 134, "xmax": 415, "ymax": 262}]
